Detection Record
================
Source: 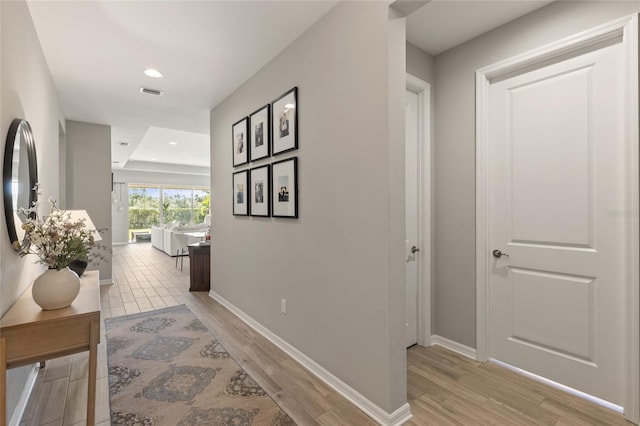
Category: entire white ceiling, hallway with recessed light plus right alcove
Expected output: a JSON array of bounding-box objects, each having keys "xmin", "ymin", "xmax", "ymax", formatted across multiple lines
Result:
[{"xmin": 27, "ymin": 0, "xmax": 550, "ymax": 172}]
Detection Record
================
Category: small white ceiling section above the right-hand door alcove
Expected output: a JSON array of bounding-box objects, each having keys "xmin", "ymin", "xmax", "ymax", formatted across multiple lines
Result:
[{"xmin": 407, "ymin": 0, "xmax": 553, "ymax": 56}]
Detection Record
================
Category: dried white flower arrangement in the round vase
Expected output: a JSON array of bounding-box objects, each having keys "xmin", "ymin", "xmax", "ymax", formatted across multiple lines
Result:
[{"xmin": 14, "ymin": 198, "xmax": 105, "ymax": 269}]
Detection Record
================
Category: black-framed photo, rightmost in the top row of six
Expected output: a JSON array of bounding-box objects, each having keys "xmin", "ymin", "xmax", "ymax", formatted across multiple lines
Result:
[{"xmin": 271, "ymin": 87, "xmax": 298, "ymax": 155}]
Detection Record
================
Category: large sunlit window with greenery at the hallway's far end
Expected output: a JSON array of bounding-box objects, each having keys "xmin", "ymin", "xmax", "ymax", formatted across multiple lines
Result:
[{"xmin": 129, "ymin": 184, "xmax": 210, "ymax": 240}]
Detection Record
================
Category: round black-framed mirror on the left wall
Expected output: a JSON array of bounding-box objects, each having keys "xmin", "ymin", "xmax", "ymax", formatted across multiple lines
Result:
[{"xmin": 2, "ymin": 118, "xmax": 38, "ymax": 250}]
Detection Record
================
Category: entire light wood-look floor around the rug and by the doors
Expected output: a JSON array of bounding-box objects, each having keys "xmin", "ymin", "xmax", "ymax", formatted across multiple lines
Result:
[{"xmin": 21, "ymin": 243, "xmax": 631, "ymax": 426}]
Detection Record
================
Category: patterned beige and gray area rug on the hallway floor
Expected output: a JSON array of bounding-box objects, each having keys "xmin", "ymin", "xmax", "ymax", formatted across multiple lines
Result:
[{"xmin": 105, "ymin": 305, "xmax": 295, "ymax": 426}]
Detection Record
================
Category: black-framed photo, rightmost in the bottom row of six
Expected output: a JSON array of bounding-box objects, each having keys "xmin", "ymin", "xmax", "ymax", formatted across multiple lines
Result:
[{"xmin": 271, "ymin": 157, "xmax": 298, "ymax": 218}]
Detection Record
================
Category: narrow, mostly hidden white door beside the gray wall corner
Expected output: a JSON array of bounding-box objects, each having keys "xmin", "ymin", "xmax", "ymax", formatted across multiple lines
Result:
[{"xmin": 405, "ymin": 90, "xmax": 419, "ymax": 347}]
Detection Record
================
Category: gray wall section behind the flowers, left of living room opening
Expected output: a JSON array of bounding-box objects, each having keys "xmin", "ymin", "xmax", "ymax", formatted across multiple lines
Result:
[{"xmin": 66, "ymin": 120, "xmax": 113, "ymax": 282}]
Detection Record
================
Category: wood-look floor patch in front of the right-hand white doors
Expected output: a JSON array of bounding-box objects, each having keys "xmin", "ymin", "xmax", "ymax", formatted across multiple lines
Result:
[{"xmin": 407, "ymin": 346, "xmax": 632, "ymax": 426}]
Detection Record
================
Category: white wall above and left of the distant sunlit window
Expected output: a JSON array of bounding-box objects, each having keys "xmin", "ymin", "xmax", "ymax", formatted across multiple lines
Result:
[{"xmin": 111, "ymin": 170, "xmax": 211, "ymax": 244}]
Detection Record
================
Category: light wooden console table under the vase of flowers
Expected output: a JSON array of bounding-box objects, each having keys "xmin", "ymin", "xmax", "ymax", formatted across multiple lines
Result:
[{"xmin": 0, "ymin": 271, "xmax": 100, "ymax": 426}]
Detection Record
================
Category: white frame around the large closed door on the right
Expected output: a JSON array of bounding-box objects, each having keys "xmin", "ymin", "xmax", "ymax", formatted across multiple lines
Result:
[{"xmin": 476, "ymin": 14, "xmax": 640, "ymax": 423}]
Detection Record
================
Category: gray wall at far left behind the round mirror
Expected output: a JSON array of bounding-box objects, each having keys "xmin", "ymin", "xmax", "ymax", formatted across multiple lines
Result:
[{"xmin": 0, "ymin": 1, "xmax": 64, "ymax": 420}]
